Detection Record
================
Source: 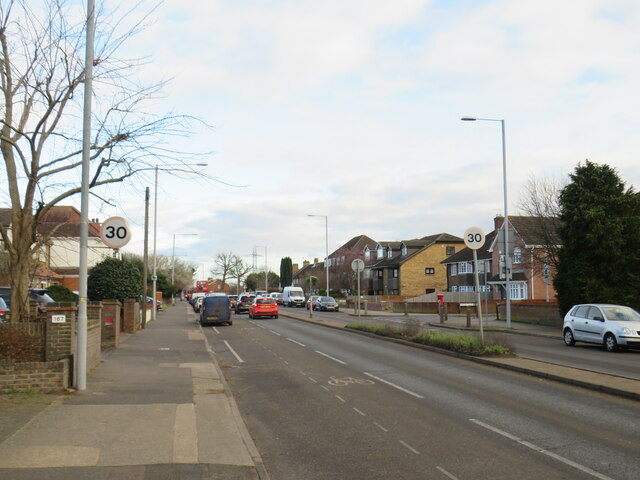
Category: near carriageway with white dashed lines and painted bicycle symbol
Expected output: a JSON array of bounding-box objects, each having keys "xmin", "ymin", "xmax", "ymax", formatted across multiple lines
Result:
[{"xmin": 204, "ymin": 315, "xmax": 640, "ymax": 480}]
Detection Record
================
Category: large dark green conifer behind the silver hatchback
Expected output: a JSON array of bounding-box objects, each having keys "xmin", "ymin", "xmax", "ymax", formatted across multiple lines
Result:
[{"xmin": 554, "ymin": 161, "xmax": 640, "ymax": 315}]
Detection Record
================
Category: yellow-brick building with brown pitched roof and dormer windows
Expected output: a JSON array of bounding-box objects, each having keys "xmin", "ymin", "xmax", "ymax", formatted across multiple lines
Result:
[{"xmin": 364, "ymin": 233, "xmax": 464, "ymax": 297}]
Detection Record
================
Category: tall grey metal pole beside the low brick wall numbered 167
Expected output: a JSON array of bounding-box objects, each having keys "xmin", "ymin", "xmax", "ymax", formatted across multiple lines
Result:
[{"xmin": 76, "ymin": 0, "xmax": 95, "ymax": 390}]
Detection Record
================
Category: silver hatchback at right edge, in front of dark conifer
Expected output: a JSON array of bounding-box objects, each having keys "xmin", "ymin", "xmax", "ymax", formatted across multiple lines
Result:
[{"xmin": 562, "ymin": 304, "xmax": 640, "ymax": 352}]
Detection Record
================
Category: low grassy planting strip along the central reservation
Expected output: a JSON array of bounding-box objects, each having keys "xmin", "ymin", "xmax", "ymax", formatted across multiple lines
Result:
[{"xmin": 346, "ymin": 323, "xmax": 511, "ymax": 356}]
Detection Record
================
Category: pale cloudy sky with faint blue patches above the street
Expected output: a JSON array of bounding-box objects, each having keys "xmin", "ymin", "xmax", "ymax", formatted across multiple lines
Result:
[{"xmin": 84, "ymin": 0, "xmax": 640, "ymax": 277}]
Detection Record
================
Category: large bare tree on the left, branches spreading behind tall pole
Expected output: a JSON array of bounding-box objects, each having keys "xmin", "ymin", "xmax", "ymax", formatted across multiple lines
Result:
[{"xmin": 0, "ymin": 0, "xmax": 205, "ymax": 321}]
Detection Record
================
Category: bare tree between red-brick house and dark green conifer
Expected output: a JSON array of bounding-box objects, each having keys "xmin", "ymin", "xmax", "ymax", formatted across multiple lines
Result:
[{"xmin": 518, "ymin": 177, "xmax": 563, "ymax": 269}]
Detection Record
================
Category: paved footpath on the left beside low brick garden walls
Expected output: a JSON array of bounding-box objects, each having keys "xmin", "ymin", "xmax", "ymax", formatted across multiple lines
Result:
[{"xmin": 0, "ymin": 304, "xmax": 268, "ymax": 480}]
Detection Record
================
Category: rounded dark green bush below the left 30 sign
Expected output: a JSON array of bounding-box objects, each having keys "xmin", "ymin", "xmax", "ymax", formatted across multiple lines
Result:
[{"xmin": 87, "ymin": 258, "xmax": 142, "ymax": 302}]
